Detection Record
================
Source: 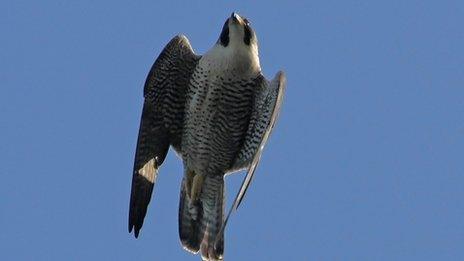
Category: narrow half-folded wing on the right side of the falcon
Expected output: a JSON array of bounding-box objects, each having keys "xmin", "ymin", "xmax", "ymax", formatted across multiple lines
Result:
[{"xmin": 218, "ymin": 71, "xmax": 286, "ymax": 238}]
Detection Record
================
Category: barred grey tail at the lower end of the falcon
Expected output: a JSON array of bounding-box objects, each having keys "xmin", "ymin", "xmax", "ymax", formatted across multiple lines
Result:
[{"xmin": 179, "ymin": 172, "xmax": 224, "ymax": 260}]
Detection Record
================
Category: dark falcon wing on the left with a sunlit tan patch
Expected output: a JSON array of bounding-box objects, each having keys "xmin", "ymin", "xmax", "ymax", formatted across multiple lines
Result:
[{"xmin": 129, "ymin": 35, "xmax": 200, "ymax": 237}]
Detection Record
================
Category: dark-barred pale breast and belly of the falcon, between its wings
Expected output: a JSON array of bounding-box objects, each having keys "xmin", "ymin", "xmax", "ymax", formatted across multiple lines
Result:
[{"xmin": 182, "ymin": 61, "xmax": 255, "ymax": 174}]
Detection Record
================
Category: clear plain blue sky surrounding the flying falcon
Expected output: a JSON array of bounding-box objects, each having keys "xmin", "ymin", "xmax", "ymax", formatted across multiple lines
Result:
[{"xmin": 0, "ymin": 0, "xmax": 464, "ymax": 260}]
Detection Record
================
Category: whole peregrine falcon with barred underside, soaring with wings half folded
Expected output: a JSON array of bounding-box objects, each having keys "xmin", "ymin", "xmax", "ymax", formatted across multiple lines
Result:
[{"xmin": 128, "ymin": 12, "xmax": 286, "ymax": 260}]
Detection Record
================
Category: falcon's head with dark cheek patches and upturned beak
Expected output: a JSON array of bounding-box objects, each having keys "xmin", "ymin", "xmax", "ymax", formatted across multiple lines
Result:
[{"xmin": 217, "ymin": 12, "xmax": 258, "ymax": 55}]
